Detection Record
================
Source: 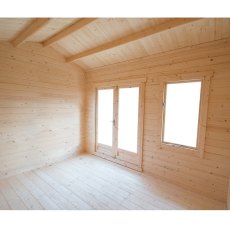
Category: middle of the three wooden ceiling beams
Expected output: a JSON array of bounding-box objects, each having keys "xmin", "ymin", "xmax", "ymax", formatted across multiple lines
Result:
[{"xmin": 42, "ymin": 18, "xmax": 96, "ymax": 46}]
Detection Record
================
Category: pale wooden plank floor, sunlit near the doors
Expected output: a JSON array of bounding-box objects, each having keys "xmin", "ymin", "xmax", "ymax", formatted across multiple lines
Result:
[{"xmin": 0, "ymin": 155, "xmax": 225, "ymax": 210}]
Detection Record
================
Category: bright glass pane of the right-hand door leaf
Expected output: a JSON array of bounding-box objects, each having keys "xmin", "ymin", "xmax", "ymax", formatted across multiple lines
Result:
[{"xmin": 118, "ymin": 87, "xmax": 139, "ymax": 153}]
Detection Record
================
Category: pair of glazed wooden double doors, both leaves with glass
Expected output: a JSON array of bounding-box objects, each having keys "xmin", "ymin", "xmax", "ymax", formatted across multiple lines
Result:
[{"xmin": 96, "ymin": 85, "xmax": 143, "ymax": 170}]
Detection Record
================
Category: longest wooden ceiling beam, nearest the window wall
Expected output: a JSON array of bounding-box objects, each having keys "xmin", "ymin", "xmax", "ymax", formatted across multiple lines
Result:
[{"xmin": 66, "ymin": 18, "xmax": 200, "ymax": 62}]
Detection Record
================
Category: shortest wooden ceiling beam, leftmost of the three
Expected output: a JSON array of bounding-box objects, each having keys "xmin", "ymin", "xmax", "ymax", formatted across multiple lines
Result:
[{"xmin": 11, "ymin": 18, "xmax": 49, "ymax": 46}]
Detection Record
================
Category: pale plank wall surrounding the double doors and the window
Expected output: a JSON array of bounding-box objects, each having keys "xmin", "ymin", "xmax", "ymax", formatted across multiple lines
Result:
[{"xmin": 86, "ymin": 39, "xmax": 230, "ymax": 202}]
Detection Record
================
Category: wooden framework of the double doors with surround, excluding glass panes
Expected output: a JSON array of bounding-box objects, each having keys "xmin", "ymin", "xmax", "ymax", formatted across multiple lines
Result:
[{"xmin": 94, "ymin": 78, "xmax": 146, "ymax": 171}]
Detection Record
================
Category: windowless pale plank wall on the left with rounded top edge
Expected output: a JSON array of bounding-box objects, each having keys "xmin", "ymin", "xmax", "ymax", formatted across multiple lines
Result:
[{"xmin": 0, "ymin": 42, "xmax": 85, "ymax": 178}]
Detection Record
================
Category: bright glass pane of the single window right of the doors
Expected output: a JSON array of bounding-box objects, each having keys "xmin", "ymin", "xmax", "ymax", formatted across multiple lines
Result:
[{"xmin": 163, "ymin": 81, "xmax": 201, "ymax": 147}]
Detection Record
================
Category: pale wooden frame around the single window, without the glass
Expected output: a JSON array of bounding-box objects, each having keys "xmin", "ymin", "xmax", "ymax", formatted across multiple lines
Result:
[{"xmin": 160, "ymin": 72, "xmax": 213, "ymax": 158}]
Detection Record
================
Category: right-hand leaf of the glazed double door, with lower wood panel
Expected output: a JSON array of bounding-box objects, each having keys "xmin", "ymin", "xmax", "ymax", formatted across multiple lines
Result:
[{"xmin": 117, "ymin": 86, "xmax": 140, "ymax": 164}]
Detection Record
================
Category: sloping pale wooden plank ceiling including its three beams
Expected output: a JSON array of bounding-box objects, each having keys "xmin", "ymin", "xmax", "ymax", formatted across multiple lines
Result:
[{"xmin": 0, "ymin": 18, "xmax": 230, "ymax": 70}]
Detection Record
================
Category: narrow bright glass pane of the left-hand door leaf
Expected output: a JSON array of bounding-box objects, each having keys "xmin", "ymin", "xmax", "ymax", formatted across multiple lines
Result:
[{"xmin": 97, "ymin": 89, "xmax": 113, "ymax": 146}]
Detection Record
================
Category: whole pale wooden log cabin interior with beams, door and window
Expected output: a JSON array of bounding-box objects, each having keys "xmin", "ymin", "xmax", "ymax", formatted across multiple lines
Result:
[{"xmin": 0, "ymin": 18, "xmax": 230, "ymax": 210}]
